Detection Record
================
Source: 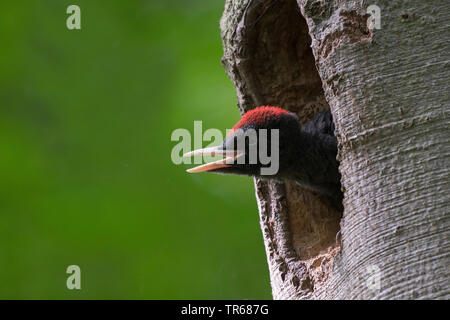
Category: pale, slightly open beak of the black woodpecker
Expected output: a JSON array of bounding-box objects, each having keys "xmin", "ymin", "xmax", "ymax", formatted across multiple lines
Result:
[{"xmin": 183, "ymin": 146, "xmax": 244, "ymax": 173}]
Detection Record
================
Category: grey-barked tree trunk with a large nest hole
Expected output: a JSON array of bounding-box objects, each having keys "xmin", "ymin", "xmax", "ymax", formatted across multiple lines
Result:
[{"xmin": 221, "ymin": 0, "xmax": 450, "ymax": 299}]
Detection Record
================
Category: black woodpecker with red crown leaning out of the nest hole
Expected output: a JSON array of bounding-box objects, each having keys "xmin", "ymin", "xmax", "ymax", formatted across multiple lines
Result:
[{"xmin": 184, "ymin": 106, "xmax": 343, "ymax": 212}]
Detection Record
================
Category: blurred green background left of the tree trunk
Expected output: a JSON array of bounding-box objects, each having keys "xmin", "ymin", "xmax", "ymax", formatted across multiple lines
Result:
[{"xmin": 0, "ymin": 0, "xmax": 271, "ymax": 299}]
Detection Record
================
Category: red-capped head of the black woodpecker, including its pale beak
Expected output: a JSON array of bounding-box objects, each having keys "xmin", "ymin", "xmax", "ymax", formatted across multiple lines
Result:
[{"xmin": 184, "ymin": 106, "xmax": 300, "ymax": 179}]
